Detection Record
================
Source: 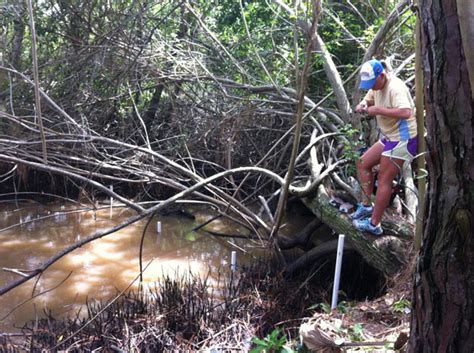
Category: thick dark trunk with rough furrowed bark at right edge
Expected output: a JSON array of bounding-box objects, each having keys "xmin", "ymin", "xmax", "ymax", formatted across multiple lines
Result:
[{"xmin": 409, "ymin": 0, "xmax": 474, "ymax": 353}]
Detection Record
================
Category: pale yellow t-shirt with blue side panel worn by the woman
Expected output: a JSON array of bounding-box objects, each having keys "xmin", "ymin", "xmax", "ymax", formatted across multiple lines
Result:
[{"xmin": 364, "ymin": 74, "xmax": 417, "ymax": 141}]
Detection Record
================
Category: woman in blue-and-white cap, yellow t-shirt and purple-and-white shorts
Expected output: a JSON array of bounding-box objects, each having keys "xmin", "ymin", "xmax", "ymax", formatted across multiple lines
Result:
[{"xmin": 350, "ymin": 60, "xmax": 417, "ymax": 235}]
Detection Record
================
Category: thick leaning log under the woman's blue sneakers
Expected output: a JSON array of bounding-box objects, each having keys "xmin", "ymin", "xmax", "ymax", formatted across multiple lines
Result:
[{"xmin": 303, "ymin": 185, "xmax": 407, "ymax": 276}]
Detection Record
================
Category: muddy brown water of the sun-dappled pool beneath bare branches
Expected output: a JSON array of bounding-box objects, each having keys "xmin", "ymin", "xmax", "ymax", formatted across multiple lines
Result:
[{"xmin": 0, "ymin": 202, "xmax": 304, "ymax": 332}]
